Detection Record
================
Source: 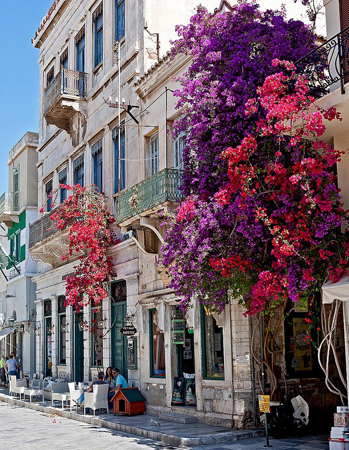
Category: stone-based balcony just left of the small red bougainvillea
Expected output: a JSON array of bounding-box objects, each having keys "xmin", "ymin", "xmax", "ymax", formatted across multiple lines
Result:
[{"xmin": 29, "ymin": 209, "xmax": 68, "ymax": 266}]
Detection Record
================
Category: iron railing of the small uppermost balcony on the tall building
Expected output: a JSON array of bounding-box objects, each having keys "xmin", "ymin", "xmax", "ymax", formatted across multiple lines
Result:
[{"xmin": 44, "ymin": 68, "xmax": 86, "ymax": 114}]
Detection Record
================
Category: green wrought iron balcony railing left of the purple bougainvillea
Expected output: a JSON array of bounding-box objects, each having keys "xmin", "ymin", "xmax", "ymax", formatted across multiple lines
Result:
[{"xmin": 116, "ymin": 169, "xmax": 183, "ymax": 223}]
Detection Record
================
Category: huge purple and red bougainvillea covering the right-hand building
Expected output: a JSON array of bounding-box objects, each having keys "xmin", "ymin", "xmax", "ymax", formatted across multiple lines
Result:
[{"xmin": 161, "ymin": 4, "xmax": 349, "ymax": 315}]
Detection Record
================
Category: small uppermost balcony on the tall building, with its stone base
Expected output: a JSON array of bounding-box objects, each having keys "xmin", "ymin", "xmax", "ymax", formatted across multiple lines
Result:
[{"xmin": 44, "ymin": 68, "xmax": 87, "ymax": 133}]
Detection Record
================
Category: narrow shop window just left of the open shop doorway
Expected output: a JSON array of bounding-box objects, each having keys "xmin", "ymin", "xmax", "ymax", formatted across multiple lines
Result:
[{"xmin": 149, "ymin": 309, "xmax": 166, "ymax": 377}]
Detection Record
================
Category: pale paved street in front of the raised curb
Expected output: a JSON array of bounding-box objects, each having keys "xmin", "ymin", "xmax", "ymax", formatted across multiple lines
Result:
[{"xmin": 0, "ymin": 403, "xmax": 328, "ymax": 450}]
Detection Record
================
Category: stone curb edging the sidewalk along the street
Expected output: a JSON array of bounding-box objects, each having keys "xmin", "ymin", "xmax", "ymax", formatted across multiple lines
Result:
[{"xmin": 0, "ymin": 394, "xmax": 264, "ymax": 447}]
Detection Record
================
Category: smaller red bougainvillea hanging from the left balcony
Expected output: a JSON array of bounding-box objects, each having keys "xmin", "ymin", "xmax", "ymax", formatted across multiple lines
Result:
[{"xmin": 44, "ymin": 184, "xmax": 118, "ymax": 309}]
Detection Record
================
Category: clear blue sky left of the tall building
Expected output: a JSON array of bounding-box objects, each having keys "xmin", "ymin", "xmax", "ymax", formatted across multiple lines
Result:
[{"xmin": 0, "ymin": 0, "xmax": 53, "ymax": 195}]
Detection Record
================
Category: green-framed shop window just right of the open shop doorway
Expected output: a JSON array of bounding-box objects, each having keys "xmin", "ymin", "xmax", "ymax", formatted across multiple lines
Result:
[{"xmin": 201, "ymin": 308, "xmax": 224, "ymax": 380}]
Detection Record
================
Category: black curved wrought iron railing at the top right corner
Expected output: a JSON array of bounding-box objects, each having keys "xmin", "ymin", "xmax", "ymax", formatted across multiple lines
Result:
[{"xmin": 295, "ymin": 27, "xmax": 349, "ymax": 94}]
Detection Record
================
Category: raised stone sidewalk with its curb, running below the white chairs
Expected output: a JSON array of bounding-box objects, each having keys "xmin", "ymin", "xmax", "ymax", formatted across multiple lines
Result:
[{"xmin": 0, "ymin": 389, "xmax": 264, "ymax": 447}]
